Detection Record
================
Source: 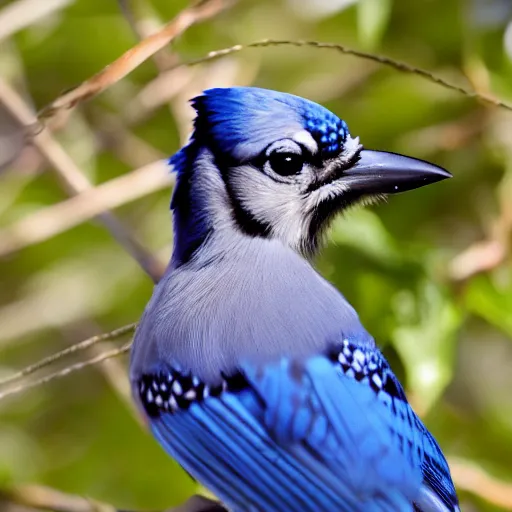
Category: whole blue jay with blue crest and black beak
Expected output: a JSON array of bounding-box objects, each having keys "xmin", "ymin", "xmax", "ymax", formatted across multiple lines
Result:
[{"xmin": 130, "ymin": 87, "xmax": 459, "ymax": 512}]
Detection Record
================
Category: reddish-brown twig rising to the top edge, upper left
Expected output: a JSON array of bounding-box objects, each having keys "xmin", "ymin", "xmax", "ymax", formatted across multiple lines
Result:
[{"xmin": 39, "ymin": 0, "xmax": 233, "ymax": 119}]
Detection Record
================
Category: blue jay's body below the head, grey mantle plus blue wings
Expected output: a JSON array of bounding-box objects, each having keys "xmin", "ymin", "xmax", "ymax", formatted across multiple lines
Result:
[{"xmin": 132, "ymin": 234, "xmax": 454, "ymax": 512}]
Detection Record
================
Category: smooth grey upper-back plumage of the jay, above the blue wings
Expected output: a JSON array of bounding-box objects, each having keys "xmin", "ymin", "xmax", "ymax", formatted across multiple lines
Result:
[{"xmin": 132, "ymin": 233, "xmax": 373, "ymax": 383}]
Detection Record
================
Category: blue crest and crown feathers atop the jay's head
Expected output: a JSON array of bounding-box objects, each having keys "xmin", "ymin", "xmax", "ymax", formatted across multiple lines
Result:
[{"xmin": 170, "ymin": 87, "xmax": 349, "ymax": 172}]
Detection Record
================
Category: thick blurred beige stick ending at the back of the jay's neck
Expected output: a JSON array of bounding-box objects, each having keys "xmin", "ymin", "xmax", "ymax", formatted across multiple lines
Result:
[{"xmin": 0, "ymin": 160, "xmax": 174, "ymax": 258}]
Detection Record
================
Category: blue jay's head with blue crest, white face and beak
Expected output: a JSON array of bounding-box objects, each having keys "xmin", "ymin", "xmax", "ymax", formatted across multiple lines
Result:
[{"xmin": 171, "ymin": 87, "xmax": 450, "ymax": 256}]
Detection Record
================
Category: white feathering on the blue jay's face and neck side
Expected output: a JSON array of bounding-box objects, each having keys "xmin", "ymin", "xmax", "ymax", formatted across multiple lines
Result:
[{"xmin": 194, "ymin": 130, "xmax": 360, "ymax": 257}]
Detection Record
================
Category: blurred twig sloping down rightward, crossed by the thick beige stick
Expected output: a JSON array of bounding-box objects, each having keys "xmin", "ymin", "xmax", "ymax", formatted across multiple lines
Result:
[{"xmin": 0, "ymin": 78, "xmax": 164, "ymax": 282}]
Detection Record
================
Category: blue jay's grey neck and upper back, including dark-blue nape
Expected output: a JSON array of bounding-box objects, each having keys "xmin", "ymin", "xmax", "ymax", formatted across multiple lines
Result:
[{"xmin": 158, "ymin": 146, "xmax": 373, "ymax": 381}]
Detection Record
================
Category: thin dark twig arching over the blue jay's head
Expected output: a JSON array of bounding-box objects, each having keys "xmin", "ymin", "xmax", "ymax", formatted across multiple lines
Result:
[{"xmin": 183, "ymin": 39, "xmax": 512, "ymax": 111}]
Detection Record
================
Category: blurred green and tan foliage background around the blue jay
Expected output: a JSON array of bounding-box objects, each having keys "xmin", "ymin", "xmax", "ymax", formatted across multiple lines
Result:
[{"xmin": 0, "ymin": 0, "xmax": 512, "ymax": 512}]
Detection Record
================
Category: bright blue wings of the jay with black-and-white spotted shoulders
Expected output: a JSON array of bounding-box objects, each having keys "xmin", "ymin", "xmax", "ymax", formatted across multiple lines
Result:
[{"xmin": 138, "ymin": 342, "xmax": 456, "ymax": 512}]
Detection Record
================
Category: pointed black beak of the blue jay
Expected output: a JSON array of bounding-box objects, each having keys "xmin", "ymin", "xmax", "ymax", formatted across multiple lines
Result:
[{"xmin": 343, "ymin": 149, "xmax": 452, "ymax": 195}]
